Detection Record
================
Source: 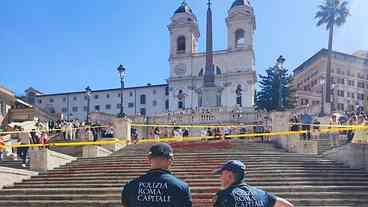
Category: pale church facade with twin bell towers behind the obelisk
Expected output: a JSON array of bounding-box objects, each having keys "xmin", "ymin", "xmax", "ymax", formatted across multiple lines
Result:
[{"xmin": 168, "ymin": 0, "xmax": 256, "ymax": 111}]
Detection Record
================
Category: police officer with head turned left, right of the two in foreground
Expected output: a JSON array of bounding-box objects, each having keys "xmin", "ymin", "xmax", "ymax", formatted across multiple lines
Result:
[{"xmin": 214, "ymin": 160, "xmax": 294, "ymax": 207}]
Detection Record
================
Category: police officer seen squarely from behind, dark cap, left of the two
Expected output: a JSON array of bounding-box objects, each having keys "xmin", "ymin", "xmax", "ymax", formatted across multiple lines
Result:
[{"xmin": 121, "ymin": 143, "xmax": 192, "ymax": 207}]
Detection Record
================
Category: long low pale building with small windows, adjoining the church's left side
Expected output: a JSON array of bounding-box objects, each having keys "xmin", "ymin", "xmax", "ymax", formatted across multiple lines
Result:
[{"xmin": 28, "ymin": 84, "xmax": 169, "ymax": 120}]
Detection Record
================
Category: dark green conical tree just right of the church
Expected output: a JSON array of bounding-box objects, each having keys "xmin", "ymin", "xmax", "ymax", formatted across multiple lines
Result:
[{"xmin": 256, "ymin": 56, "xmax": 296, "ymax": 111}]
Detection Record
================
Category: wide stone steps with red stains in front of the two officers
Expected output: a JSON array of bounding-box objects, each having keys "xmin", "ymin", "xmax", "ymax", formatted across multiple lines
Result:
[{"xmin": 0, "ymin": 140, "xmax": 368, "ymax": 207}]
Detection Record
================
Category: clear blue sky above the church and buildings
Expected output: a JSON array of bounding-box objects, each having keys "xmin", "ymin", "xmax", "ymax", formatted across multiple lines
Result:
[{"xmin": 0, "ymin": 0, "xmax": 368, "ymax": 95}]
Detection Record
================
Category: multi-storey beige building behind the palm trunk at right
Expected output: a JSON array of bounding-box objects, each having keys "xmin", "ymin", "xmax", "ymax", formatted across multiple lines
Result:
[{"xmin": 294, "ymin": 49, "xmax": 368, "ymax": 111}]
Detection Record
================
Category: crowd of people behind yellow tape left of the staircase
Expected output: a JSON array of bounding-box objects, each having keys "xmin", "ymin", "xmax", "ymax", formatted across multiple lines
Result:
[{"xmin": 0, "ymin": 120, "xmax": 114, "ymax": 167}]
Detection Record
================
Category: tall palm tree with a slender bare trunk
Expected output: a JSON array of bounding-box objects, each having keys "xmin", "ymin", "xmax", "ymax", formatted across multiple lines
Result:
[{"xmin": 314, "ymin": 0, "xmax": 350, "ymax": 109}]
